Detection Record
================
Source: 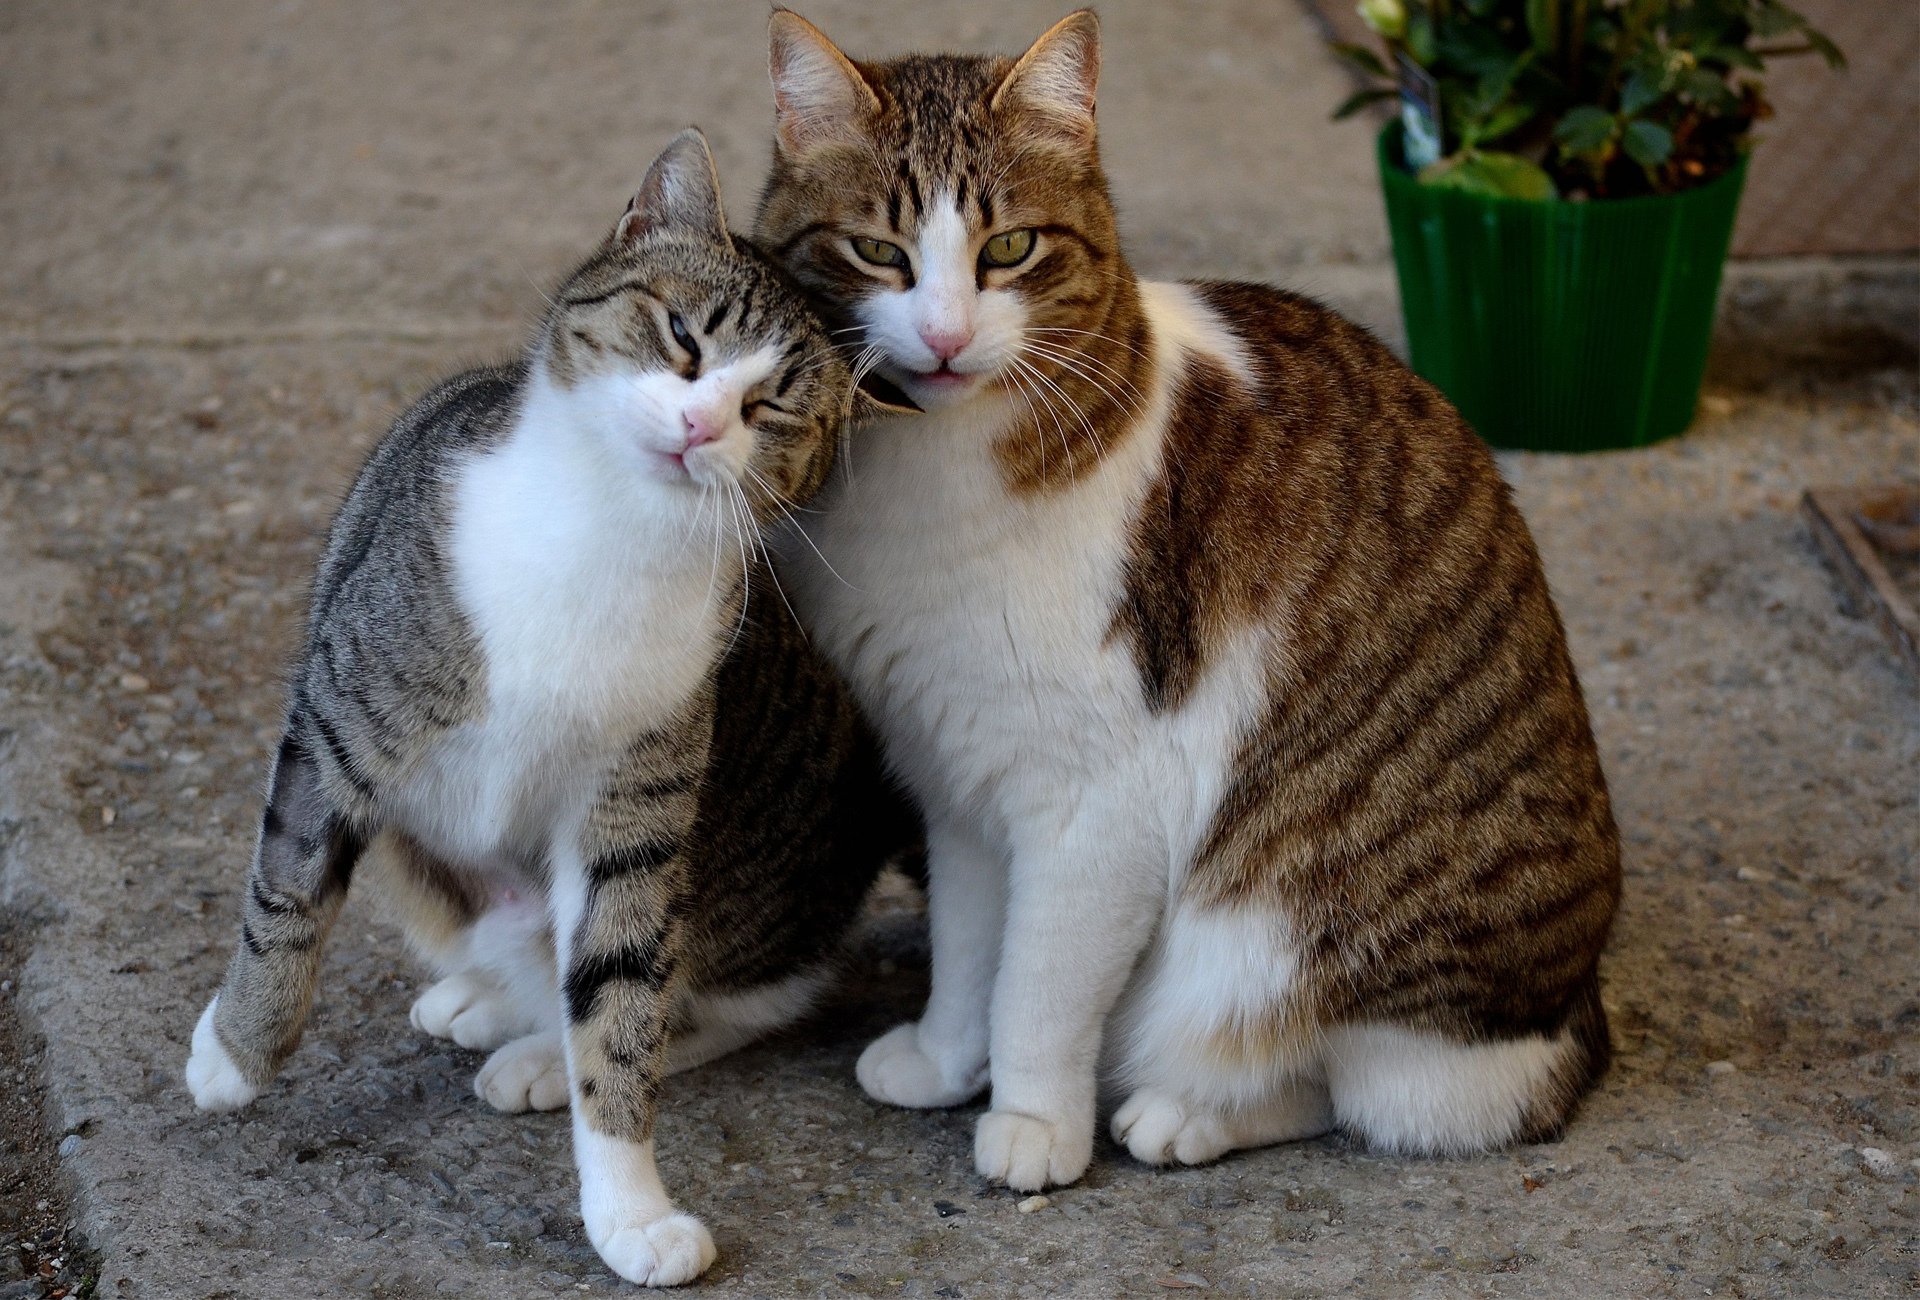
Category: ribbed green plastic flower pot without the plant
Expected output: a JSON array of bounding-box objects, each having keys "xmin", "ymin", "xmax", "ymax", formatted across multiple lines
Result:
[{"xmin": 1379, "ymin": 123, "xmax": 1747, "ymax": 451}]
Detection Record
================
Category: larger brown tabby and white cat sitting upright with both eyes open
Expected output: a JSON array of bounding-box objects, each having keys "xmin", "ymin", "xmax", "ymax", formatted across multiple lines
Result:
[{"xmin": 755, "ymin": 10, "xmax": 1620, "ymax": 1191}]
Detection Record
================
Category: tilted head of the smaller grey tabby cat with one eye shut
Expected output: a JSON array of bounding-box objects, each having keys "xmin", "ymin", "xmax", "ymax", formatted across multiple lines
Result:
[{"xmin": 538, "ymin": 129, "xmax": 910, "ymax": 524}]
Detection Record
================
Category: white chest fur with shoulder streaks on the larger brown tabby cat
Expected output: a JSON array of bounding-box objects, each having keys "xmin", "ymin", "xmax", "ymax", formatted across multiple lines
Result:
[{"xmin": 785, "ymin": 288, "xmax": 1267, "ymax": 862}]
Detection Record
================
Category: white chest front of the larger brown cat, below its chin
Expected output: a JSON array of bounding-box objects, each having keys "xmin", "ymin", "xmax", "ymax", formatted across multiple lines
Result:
[{"xmin": 789, "ymin": 389, "xmax": 1152, "ymax": 818}]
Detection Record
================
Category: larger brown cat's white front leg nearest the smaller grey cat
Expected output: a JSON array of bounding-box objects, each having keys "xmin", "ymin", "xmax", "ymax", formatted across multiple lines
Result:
[{"xmin": 854, "ymin": 816, "xmax": 1006, "ymax": 1108}]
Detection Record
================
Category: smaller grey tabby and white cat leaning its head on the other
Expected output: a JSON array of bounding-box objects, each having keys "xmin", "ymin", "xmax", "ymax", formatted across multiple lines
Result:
[{"xmin": 186, "ymin": 131, "xmax": 918, "ymax": 1285}]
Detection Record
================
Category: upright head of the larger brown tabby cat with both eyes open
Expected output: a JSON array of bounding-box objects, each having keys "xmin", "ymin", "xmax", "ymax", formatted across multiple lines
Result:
[{"xmin": 756, "ymin": 10, "xmax": 1131, "ymax": 405}]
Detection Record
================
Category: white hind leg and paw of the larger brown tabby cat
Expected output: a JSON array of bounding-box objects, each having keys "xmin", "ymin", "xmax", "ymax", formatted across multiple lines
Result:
[{"xmin": 1112, "ymin": 903, "xmax": 1332, "ymax": 1164}]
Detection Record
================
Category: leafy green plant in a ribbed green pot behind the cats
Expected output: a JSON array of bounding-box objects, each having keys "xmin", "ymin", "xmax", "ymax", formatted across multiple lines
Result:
[{"xmin": 1334, "ymin": 0, "xmax": 1843, "ymax": 449}]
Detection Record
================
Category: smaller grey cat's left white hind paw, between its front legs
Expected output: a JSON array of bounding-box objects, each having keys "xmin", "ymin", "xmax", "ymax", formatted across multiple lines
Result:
[{"xmin": 409, "ymin": 891, "xmax": 559, "ymax": 1050}]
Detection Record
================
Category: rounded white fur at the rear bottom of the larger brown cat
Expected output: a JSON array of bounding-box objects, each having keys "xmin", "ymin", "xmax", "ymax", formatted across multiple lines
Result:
[{"xmin": 1325, "ymin": 985, "xmax": 1609, "ymax": 1156}]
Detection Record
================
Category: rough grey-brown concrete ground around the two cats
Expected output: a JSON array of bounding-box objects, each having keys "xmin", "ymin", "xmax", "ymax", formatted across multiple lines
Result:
[{"xmin": 0, "ymin": 0, "xmax": 1920, "ymax": 1298}]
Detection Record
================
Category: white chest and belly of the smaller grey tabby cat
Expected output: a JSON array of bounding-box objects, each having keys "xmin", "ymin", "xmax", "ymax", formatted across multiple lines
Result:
[{"xmin": 399, "ymin": 418, "xmax": 722, "ymax": 868}]
